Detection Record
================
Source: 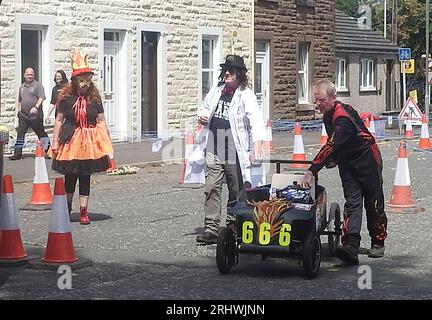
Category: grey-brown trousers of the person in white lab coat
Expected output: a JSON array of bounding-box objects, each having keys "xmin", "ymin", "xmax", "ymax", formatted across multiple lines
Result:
[{"xmin": 204, "ymin": 152, "xmax": 243, "ymax": 235}]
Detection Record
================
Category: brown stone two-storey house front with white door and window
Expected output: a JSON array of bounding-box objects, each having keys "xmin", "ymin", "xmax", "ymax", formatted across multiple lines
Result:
[{"xmin": 254, "ymin": 0, "xmax": 335, "ymax": 120}]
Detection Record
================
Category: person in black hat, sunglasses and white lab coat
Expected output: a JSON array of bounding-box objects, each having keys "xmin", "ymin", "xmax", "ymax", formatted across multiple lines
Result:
[{"xmin": 196, "ymin": 55, "xmax": 266, "ymax": 244}]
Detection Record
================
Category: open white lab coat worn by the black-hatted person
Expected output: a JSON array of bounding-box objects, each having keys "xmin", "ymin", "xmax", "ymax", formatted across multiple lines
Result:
[{"xmin": 197, "ymin": 84, "xmax": 267, "ymax": 187}]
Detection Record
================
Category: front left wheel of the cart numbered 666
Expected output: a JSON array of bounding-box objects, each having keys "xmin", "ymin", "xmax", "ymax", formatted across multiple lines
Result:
[{"xmin": 216, "ymin": 228, "xmax": 236, "ymax": 274}]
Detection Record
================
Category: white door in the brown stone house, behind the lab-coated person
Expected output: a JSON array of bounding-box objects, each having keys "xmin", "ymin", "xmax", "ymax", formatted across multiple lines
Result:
[{"xmin": 254, "ymin": 41, "xmax": 270, "ymax": 120}]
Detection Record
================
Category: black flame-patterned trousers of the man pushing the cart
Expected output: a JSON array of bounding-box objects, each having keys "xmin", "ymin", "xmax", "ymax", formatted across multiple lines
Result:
[{"xmin": 339, "ymin": 155, "xmax": 387, "ymax": 247}]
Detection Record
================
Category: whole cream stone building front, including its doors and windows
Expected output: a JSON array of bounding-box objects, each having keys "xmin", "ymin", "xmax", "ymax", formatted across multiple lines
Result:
[{"xmin": 0, "ymin": 0, "xmax": 254, "ymax": 141}]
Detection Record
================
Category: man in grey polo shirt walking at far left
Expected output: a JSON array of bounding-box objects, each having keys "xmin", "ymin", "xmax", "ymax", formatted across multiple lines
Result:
[{"xmin": 9, "ymin": 68, "xmax": 50, "ymax": 160}]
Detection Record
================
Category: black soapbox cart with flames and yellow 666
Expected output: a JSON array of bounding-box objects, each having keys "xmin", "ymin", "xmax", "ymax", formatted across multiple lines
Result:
[{"xmin": 216, "ymin": 160, "xmax": 342, "ymax": 278}]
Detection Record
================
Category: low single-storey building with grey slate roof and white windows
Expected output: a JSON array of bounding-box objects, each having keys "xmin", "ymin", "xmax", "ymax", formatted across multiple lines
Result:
[{"xmin": 335, "ymin": 10, "xmax": 403, "ymax": 114}]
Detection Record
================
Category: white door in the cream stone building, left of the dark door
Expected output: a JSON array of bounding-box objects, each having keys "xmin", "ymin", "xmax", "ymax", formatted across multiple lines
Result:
[{"xmin": 102, "ymin": 41, "xmax": 120, "ymax": 141}]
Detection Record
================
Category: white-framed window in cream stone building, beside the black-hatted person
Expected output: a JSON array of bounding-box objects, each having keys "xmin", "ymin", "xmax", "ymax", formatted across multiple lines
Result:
[{"xmin": 201, "ymin": 36, "xmax": 217, "ymax": 98}]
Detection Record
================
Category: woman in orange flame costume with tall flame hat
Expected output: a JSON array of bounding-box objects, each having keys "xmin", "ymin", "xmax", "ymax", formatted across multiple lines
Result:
[{"xmin": 50, "ymin": 49, "xmax": 113, "ymax": 224}]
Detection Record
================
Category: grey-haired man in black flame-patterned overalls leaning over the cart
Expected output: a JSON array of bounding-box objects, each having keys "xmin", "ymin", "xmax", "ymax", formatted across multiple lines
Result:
[{"xmin": 302, "ymin": 80, "xmax": 387, "ymax": 265}]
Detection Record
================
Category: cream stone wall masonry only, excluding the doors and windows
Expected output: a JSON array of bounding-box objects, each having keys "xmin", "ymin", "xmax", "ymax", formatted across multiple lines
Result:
[{"xmin": 0, "ymin": 0, "xmax": 253, "ymax": 139}]
